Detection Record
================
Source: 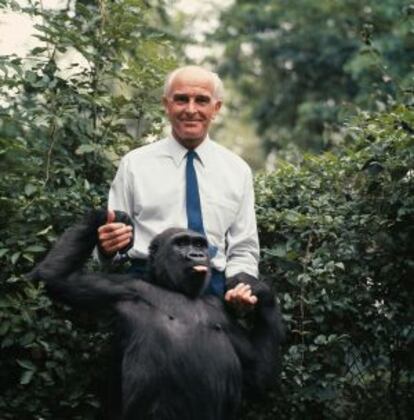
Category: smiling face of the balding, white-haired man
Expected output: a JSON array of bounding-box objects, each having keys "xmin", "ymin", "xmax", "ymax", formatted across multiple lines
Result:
[{"xmin": 163, "ymin": 72, "xmax": 221, "ymax": 149}]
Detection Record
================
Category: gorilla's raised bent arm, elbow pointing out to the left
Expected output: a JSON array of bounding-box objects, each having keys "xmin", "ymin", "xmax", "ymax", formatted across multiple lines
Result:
[{"xmin": 29, "ymin": 211, "xmax": 138, "ymax": 310}]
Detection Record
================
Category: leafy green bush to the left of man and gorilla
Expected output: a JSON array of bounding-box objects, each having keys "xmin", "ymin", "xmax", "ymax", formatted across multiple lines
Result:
[{"xmin": 0, "ymin": 0, "xmax": 174, "ymax": 420}]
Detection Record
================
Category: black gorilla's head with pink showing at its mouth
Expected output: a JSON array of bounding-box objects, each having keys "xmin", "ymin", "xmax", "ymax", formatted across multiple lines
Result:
[{"xmin": 149, "ymin": 228, "xmax": 210, "ymax": 297}]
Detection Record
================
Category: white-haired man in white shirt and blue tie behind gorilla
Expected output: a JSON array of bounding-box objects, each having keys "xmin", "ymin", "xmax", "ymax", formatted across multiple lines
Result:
[{"xmin": 98, "ymin": 66, "xmax": 259, "ymax": 307}]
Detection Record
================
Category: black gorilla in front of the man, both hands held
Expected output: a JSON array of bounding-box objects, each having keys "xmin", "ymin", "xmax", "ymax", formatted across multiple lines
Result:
[{"xmin": 31, "ymin": 210, "xmax": 282, "ymax": 420}]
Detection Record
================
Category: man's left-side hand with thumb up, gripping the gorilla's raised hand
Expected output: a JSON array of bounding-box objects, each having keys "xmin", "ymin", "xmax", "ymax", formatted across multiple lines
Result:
[{"xmin": 98, "ymin": 210, "xmax": 132, "ymax": 257}]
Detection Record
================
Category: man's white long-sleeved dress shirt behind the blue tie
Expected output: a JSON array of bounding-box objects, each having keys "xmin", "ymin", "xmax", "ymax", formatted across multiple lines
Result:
[{"xmin": 108, "ymin": 136, "xmax": 259, "ymax": 278}]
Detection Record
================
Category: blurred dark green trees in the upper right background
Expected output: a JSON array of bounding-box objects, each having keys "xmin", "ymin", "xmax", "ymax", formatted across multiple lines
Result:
[{"xmin": 213, "ymin": 0, "xmax": 414, "ymax": 152}]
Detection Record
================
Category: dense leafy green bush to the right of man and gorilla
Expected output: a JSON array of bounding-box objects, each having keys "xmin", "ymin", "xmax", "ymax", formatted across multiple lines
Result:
[{"xmin": 246, "ymin": 107, "xmax": 414, "ymax": 420}]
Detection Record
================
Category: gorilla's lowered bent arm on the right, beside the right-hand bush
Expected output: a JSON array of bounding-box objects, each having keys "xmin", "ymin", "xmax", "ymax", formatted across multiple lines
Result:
[{"xmin": 227, "ymin": 273, "xmax": 284, "ymax": 396}]
